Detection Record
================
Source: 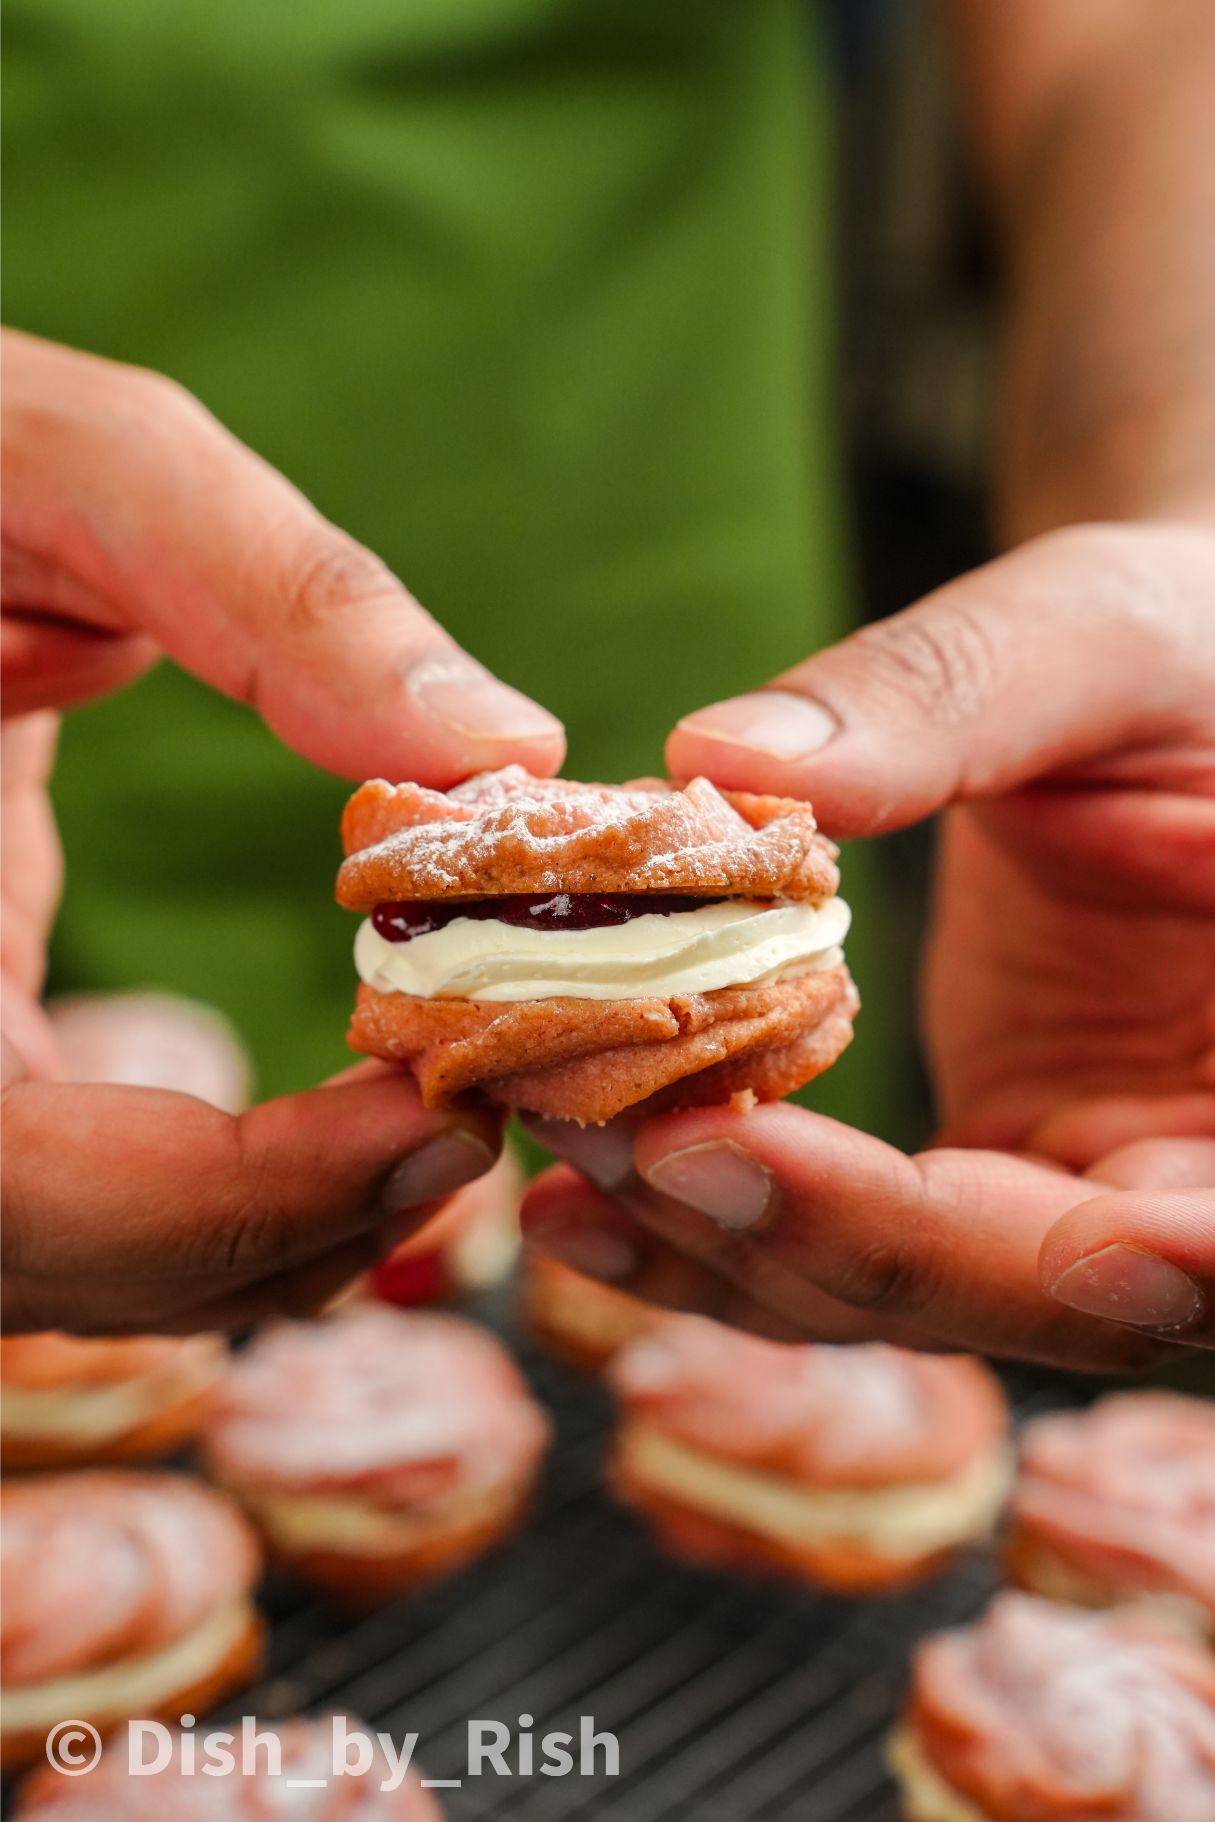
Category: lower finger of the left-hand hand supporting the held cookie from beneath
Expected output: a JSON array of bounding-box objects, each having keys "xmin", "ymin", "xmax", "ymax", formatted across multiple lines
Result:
[{"xmin": 4, "ymin": 1064, "xmax": 499, "ymax": 1334}]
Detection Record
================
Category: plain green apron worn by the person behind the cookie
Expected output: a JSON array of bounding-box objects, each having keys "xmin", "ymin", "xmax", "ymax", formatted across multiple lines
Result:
[{"xmin": 5, "ymin": 0, "xmax": 903, "ymax": 1128}]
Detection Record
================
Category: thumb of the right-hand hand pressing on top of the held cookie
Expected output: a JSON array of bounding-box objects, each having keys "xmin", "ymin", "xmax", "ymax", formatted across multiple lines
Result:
[{"xmin": 667, "ymin": 525, "xmax": 1215, "ymax": 836}]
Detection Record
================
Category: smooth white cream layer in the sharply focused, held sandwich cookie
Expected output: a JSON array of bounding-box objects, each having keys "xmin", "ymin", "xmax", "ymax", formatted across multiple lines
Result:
[{"xmin": 355, "ymin": 898, "xmax": 851, "ymax": 1000}]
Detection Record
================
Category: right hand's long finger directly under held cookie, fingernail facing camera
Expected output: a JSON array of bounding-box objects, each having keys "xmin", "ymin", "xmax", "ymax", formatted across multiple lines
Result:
[{"xmin": 630, "ymin": 1104, "xmax": 1162, "ymax": 1368}]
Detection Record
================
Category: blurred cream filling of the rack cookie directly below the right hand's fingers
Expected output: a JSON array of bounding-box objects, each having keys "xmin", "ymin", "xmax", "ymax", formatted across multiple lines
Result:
[{"xmin": 619, "ymin": 1423, "xmax": 1013, "ymax": 1558}]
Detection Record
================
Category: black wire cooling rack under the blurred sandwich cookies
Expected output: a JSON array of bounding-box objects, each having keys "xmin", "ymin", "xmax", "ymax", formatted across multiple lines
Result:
[{"xmin": 197, "ymin": 1299, "xmax": 1082, "ymax": 1822}]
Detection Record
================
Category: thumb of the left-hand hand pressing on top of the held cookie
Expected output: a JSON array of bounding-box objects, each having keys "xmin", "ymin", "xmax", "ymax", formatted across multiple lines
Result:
[{"xmin": 4, "ymin": 333, "xmax": 565, "ymax": 785}]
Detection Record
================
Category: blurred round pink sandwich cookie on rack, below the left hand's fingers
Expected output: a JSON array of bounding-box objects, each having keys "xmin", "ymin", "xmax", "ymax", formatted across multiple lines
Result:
[{"xmin": 204, "ymin": 1303, "xmax": 548, "ymax": 1603}]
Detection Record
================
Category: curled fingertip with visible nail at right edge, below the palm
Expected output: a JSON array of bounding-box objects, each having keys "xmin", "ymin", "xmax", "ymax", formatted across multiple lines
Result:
[{"xmin": 1038, "ymin": 1188, "xmax": 1215, "ymax": 1348}]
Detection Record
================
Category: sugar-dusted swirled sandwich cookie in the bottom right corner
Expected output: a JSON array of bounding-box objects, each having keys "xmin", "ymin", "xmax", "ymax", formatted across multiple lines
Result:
[{"xmin": 891, "ymin": 1594, "xmax": 1215, "ymax": 1822}]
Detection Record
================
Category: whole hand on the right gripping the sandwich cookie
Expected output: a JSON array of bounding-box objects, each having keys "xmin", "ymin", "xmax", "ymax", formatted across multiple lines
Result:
[{"xmin": 525, "ymin": 523, "xmax": 1215, "ymax": 1367}]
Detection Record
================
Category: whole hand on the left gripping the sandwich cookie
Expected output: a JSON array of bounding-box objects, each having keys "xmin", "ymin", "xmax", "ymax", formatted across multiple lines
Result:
[{"xmin": 0, "ymin": 335, "xmax": 563, "ymax": 1332}]
